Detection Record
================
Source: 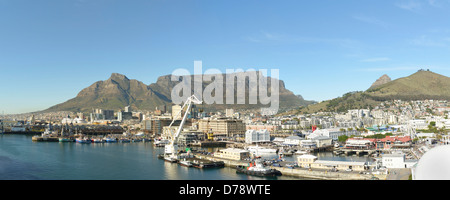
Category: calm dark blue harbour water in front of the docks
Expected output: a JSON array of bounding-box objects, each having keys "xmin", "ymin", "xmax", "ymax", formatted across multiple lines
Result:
[{"xmin": 0, "ymin": 134, "xmax": 366, "ymax": 180}]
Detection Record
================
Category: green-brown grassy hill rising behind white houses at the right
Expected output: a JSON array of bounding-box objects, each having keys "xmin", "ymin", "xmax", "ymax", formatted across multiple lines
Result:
[{"xmin": 288, "ymin": 70, "xmax": 450, "ymax": 114}]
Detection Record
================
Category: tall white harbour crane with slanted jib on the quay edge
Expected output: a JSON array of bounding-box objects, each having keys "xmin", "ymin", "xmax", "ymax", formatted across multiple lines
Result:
[{"xmin": 164, "ymin": 95, "xmax": 202, "ymax": 162}]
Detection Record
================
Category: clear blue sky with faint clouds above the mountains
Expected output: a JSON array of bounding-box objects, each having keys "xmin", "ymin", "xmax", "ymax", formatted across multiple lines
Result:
[{"xmin": 0, "ymin": 0, "xmax": 450, "ymax": 114}]
